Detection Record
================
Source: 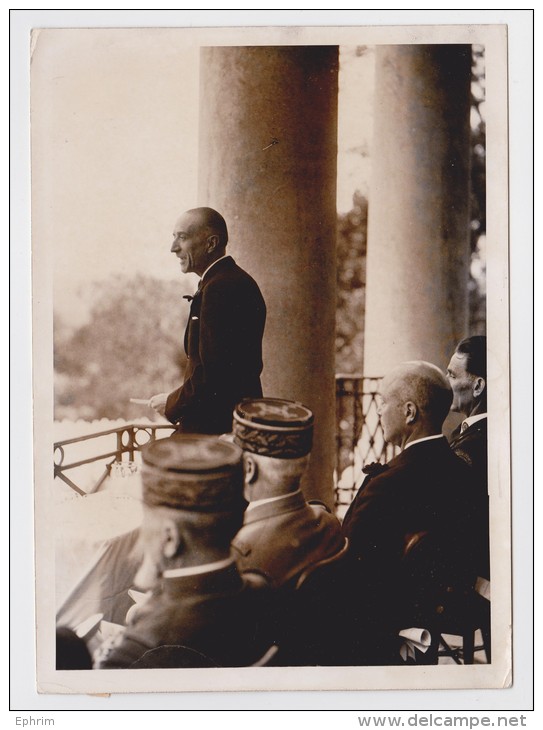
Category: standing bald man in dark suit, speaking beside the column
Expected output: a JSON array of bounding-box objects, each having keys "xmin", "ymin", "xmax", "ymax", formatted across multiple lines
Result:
[{"xmin": 149, "ymin": 208, "xmax": 266, "ymax": 434}]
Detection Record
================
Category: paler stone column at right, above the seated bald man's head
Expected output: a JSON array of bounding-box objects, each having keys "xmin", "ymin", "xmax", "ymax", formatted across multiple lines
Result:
[{"xmin": 364, "ymin": 45, "xmax": 471, "ymax": 376}]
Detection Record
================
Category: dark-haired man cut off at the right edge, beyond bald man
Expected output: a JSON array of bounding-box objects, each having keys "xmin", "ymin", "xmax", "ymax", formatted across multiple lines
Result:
[{"xmin": 447, "ymin": 335, "xmax": 490, "ymax": 581}]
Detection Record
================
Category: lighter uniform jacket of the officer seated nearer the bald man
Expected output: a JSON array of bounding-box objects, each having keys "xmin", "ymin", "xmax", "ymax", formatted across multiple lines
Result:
[{"xmin": 232, "ymin": 492, "xmax": 345, "ymax": 587}]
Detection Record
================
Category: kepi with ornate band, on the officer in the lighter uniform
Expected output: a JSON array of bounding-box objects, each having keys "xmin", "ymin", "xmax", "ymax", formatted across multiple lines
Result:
[{"xmin": 232, "ymin": 398, "xmax": 313, "ymax": 459}]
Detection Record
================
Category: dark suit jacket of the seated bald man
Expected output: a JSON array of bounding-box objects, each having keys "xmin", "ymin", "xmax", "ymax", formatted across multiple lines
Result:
[{"xmin": 342, "ymin": 437, "xmax": 475, "ymax": 654}]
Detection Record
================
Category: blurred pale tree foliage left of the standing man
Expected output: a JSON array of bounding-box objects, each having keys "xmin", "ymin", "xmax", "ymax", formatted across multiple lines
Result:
[{"xmin": 54, "ymin": 275, "xmax": 192, "ymax": 420}]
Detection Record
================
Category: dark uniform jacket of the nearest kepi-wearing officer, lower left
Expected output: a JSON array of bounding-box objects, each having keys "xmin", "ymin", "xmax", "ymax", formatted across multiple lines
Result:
[{"xmin": 95, "ymin": 565, "xmax": 268, "ymax": 669}]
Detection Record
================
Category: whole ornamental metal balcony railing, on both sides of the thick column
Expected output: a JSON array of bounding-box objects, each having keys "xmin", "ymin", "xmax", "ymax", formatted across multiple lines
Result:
[{"xmin": 54, "ymin": 374, "xmax": 395, "ymax": 510}]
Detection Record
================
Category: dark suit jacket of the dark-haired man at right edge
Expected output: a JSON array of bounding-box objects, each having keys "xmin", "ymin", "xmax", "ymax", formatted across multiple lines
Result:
[{"xmin": 450, "ymin": 418, "xmax": 490, "ymax": 580}]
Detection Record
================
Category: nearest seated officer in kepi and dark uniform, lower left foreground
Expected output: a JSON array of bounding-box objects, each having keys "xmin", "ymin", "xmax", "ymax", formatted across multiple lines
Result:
[{"xmin": 94, "ymin": 436, "xmax": 274, "ymax": 669}]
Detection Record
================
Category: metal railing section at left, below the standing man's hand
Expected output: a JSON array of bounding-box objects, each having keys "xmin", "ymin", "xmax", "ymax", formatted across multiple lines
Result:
[{"xmin": 53, "ymin": 423, "xmax": 174, "ymax": 495}]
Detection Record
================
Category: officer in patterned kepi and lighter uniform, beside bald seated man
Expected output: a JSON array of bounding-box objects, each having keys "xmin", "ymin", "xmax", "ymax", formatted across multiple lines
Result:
[{"xmin": 232, "ymin": 398, "xmax": 345, "ymax": 588}]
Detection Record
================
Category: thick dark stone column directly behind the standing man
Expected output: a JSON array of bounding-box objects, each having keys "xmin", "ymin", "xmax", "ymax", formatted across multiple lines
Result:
[{"xmin": 199, "ymin": 46, "xmax": 338, "ymax": 506}]
